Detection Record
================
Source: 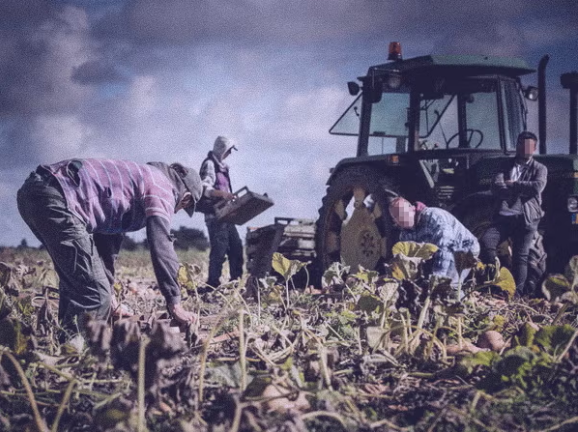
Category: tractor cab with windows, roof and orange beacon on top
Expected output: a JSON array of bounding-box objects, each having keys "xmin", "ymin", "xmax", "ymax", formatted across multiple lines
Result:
[{"xmin": 330, "ymin": 45, "xmax": 535, "ymax": 156}]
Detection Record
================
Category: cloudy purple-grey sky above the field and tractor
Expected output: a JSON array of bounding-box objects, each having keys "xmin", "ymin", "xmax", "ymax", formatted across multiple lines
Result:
[{"xmin": 0, "ymin": 0, "xmax": 578, "ymax": 246}]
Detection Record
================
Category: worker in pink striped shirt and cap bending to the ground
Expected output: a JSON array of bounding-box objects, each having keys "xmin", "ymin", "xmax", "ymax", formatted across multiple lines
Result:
[{"xmin": 17, "ymin": 159, "xmax": 203, "ymax": 348}]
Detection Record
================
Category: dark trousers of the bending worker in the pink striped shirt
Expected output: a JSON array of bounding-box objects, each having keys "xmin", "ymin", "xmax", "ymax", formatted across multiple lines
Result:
[{"xmin": 17, "ymin": 172, "xmax": 120, "ymax": 337}]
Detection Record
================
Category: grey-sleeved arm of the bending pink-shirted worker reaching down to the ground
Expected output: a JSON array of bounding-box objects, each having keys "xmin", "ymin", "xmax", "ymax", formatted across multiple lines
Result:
[{"xmin": 146, "ymin": 216, "xmax": 194, "ymax": 323}]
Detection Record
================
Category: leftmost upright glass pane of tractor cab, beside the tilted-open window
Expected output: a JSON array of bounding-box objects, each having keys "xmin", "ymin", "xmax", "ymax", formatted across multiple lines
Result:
[{"xmin": 368, "ymin": 92, "xmax": 409, "ymax": 155}]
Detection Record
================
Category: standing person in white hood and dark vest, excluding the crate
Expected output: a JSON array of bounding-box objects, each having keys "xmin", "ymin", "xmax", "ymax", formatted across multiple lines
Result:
[{"xmin": 199, "ymin": 136, "xmax": 243, "ymax": 292}]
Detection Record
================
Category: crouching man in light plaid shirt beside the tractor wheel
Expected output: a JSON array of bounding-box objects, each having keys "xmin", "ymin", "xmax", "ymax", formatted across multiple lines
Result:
[{"xmin": 389, "ymin": 197, "xmax": 480, "ymax": 284}]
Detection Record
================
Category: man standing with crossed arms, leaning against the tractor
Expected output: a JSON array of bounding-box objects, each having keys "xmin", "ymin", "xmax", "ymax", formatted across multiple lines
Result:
[{"xmin": 480, "ymin": 132, "xmax": 548, "ymax": 296}]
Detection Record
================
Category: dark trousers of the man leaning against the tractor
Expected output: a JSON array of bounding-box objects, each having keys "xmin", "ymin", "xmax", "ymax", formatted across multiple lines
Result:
[{"xmin": 480, "ymin": 215, "xmax": 538, "ymax": 295}]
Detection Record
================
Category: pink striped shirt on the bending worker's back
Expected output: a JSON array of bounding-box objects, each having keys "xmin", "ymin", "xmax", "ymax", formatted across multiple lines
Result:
[{"xmin": 44, "ymin": 159, "xmax": 178, "ymax": 234}]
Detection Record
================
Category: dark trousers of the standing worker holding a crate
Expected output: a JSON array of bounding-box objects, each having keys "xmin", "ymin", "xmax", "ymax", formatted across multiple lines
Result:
[{"xmin": 206, "ymin": 218, "xmax": 243, "ymax": 287}]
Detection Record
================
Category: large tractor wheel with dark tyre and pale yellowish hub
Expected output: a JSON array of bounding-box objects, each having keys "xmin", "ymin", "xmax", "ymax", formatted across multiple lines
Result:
[{"xmin": 315, "ymin": 166, "xmax": 394, "ymax": 272}]
